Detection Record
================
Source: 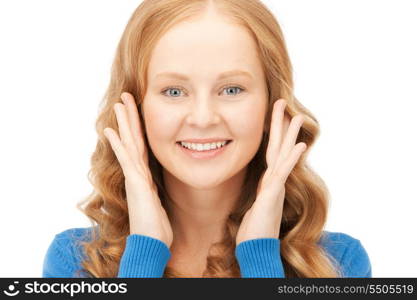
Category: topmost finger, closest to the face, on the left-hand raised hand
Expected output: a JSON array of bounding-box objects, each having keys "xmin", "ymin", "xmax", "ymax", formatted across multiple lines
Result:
[{"xmin": 121, "ymin": 92, "xmax": 145, "ymax": 161}]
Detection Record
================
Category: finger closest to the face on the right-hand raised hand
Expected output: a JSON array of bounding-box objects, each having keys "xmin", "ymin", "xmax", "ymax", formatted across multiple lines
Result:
[{"xmin": 266, "ymin": 99, "xmax": 286, "ymax": 168}]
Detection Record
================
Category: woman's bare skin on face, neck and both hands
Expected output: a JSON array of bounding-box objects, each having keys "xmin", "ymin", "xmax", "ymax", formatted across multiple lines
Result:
[{"xmin": 104, "ymin": 10, "xmax": 306, "ymax": 274}]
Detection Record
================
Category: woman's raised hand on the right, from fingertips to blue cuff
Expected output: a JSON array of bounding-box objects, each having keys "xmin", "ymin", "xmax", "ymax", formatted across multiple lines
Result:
[{"xmin": 236, "ymin": 99, "xmax": 307, "ymax": 245}]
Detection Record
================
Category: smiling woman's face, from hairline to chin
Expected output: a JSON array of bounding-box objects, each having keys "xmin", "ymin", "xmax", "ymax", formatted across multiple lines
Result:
[{"xmin": 143, "ymin": 15, "xmax": 267, "ymax": 189}]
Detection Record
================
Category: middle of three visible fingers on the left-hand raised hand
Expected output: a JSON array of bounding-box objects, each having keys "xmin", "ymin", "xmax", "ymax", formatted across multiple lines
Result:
[{"xmin": 114, "ymin": 103, "xmax": 140, "ymax": 164}]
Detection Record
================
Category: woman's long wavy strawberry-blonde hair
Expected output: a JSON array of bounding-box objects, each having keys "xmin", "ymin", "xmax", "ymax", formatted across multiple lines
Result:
[{"xmin": 77, "ymin": 0, "xmax": 340, "ymax": 277}]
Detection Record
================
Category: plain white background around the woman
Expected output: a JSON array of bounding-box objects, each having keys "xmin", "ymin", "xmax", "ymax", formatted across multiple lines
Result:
[{"xmin": 0, "ymin": 0, "xmax": 417, "ymax": 277}]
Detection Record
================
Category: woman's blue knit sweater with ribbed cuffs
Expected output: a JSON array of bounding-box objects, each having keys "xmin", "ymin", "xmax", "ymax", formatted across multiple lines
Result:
[{"xmin": 42, "ymin": 227, "xmax": 372, "ymax": 278}]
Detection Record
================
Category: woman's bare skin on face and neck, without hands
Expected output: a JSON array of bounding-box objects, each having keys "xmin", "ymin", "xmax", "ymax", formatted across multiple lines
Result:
[{"xmin": 143, "ymin": 14, "xmax": 267, "ymax": 255}]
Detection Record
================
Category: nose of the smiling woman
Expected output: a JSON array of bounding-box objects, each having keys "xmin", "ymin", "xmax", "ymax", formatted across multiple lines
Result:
[{"xmin": 187, "ymin": 96, "xmax": 220, "ymax": 128}]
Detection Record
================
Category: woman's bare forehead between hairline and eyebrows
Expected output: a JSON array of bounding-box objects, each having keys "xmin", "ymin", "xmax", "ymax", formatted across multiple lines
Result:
[{"xmin": 148, "ymin": 17, "xmax": 262, "ymax": 80}]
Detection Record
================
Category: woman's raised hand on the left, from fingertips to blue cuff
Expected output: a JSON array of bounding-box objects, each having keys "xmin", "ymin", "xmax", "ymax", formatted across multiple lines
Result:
[{"xmin": 104, "ymin": 92, "xmax": 173, "ymax": 248}]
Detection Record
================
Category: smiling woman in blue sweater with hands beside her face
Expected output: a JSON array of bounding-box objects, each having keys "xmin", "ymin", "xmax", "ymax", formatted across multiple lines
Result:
[{"xmin": 43, "ymin": 0, "xmax": 371, "ymax": 277}]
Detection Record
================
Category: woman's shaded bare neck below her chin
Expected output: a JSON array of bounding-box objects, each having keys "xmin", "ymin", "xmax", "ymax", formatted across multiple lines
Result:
[{"xmin": 164, "ymin": 168, "xmax": 246, "ymax": 252}]
